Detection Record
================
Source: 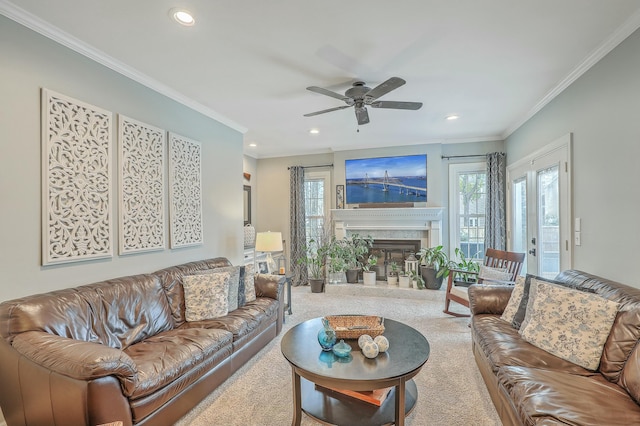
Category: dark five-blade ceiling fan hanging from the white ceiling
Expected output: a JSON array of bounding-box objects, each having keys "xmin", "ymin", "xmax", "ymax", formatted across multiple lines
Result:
[{"xmin": 304, "ymin": 77, "xmax": 422, "ymax": 125}]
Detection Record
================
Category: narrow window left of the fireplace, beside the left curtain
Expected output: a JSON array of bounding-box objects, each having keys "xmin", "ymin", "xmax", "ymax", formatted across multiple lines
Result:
[{"xmin": 304, "ymin": 172, "xmax": 332, "ymax": 246}]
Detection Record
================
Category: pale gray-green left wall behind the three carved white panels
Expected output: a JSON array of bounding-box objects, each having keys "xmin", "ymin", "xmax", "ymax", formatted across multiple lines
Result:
[{"xmin": 0, "ymin": 16, "xmax": 243, "ymax": 301}]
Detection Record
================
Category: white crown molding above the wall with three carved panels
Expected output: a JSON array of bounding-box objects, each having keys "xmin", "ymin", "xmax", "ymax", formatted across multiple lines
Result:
[{"xmin": 0, "ymin": 0, "xmax": 248, "ymax": 134}]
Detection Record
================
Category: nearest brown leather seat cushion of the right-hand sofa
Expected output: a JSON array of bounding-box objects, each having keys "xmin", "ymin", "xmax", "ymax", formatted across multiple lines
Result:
[{"xmin": 497, "ymin": 367, "xmax": 640, "ymax": 426}]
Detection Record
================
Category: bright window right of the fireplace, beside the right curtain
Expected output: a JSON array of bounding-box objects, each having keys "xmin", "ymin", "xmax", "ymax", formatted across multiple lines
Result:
[{"xmin": 449, "ymin": 163, "xmax": 487, "ymax": 259}]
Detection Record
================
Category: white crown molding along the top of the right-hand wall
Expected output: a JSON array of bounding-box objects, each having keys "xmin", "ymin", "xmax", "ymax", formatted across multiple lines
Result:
[{"xmin": 501, "ymin": 9, "xmax": 640, "ymax": 140}]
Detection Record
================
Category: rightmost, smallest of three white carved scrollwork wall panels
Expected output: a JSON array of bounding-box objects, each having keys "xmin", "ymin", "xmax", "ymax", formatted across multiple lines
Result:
[{"xmin": 169, "ymin": 133, "xmax": 203, "ymax": 248}]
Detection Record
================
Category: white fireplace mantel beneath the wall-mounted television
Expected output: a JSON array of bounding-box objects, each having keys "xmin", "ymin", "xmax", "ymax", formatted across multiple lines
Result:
[{"xmin": 331, "ymin": 207, "xmax": 444, "ymax": 246}]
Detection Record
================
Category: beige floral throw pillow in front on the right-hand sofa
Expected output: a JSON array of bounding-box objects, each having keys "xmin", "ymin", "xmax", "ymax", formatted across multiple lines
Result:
[{"xmin": 519, "ymin": 278, "xmax": 618, "ymax": 371}]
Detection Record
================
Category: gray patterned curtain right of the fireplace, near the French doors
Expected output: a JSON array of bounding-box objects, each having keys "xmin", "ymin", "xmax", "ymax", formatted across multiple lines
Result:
[{"xmin": 484, "ymin": 152, "xmax": 507, "ymax": 250}]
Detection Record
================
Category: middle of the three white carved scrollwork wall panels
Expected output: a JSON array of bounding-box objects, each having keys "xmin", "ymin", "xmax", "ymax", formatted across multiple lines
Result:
[{"xmin": 118, "ymin": 114, "xmax": 166, "ymax": 254}]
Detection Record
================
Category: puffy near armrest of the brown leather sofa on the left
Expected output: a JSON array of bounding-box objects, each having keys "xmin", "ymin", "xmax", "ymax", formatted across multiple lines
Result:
[{"xmin": 12, "ymin": 331, "xmax": 137, "ymax": 395}]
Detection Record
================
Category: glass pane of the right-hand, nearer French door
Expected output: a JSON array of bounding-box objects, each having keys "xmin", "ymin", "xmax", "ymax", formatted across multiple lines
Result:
[{"xmin": 537, "ymin": 165, "xmax": 560, "ymax": 278}]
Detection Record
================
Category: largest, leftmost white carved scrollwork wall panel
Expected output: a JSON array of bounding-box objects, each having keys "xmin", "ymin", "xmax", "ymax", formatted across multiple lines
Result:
[{"xmin": 42, "ymin": 89, "xmax": 112, "ymax": 265}]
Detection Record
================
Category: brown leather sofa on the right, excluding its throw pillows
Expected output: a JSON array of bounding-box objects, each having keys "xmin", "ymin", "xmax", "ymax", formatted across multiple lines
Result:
[{"xmin": 469, "ymin": 270, "xmax": 640, "ymax": 426}]
